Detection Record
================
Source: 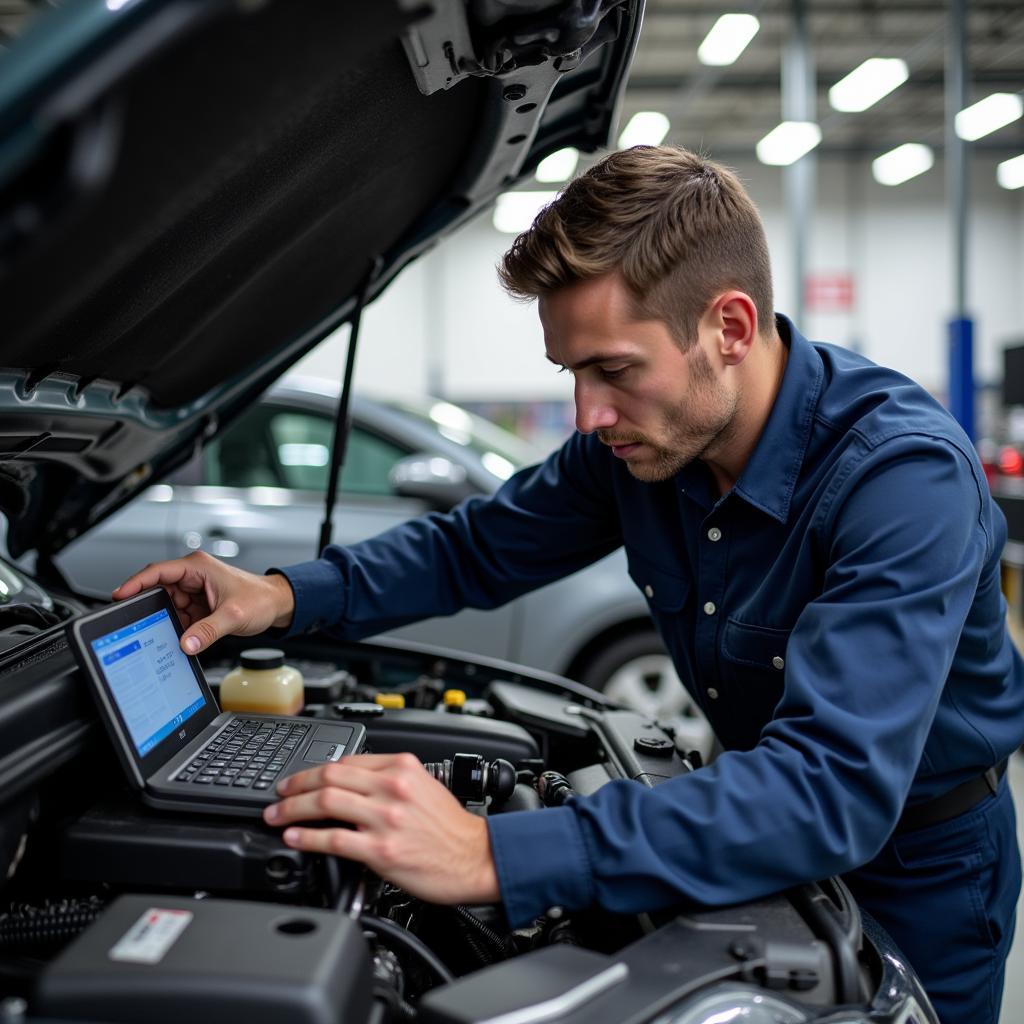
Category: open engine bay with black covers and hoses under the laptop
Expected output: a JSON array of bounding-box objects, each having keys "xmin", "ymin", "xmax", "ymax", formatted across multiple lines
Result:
[{"xmin": 0, "ymin": 610, "xmax": 883, "ymax": 1022}]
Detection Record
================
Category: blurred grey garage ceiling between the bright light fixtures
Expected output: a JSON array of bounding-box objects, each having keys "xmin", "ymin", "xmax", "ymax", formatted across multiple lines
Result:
[{"xmin": 623, "ymin": 0, "xmax": 1024, "ymax": 160}]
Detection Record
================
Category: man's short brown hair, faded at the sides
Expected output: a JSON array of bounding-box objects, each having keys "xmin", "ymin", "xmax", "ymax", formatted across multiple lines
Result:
[{"xmin": 498, "ymin": 145, "xmax": 775, "ymax": 348}]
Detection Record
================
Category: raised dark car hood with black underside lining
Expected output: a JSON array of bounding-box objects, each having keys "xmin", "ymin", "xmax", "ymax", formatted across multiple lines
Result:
[{"xmin": 0, "ymin": 0, "xmax": 642, "ymax": 562}]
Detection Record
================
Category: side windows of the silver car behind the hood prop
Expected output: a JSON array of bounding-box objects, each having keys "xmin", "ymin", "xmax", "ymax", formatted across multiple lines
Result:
[{"xmin": 204, "ymin": 407, "xmax": 410, "ymax": 497}]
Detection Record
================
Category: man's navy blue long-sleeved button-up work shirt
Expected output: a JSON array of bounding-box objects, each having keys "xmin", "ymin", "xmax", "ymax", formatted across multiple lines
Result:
[{"xmin": 276, "ymin": 317, "xmax": 1024, "ymax": 926}]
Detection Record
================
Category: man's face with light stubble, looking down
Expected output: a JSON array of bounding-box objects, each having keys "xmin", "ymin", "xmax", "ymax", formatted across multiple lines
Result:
[{"xmin": 540, "ymin": 274, "xmax": 739, "ymax": 482}]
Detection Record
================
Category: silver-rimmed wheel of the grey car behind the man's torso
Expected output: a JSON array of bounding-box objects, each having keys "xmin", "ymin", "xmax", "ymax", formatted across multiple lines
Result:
[{"xmin": 580, "ymin": 630, "xmax": 715, "ymax": 761}]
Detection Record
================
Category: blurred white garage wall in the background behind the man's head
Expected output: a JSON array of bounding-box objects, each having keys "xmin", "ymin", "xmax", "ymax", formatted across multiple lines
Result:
[{"xmin": 300, "ymin": 157, "xmax": 1024, "ymax": 400}]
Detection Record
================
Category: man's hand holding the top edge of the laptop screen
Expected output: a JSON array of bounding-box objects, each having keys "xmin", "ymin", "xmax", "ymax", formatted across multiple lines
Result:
[{"xmin": 112, "ymin": 551, "xmax": 295, "ymax": 654}]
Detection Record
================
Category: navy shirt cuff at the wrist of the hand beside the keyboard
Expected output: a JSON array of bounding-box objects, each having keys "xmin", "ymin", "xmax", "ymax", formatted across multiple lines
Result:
[{"xmin": 487, "ymin": 807, "xmax": 594, "ymax": 928}]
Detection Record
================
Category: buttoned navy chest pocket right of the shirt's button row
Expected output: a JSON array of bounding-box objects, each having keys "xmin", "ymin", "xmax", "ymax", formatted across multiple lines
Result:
[{"xmin": 720, "ymin": 618, "xmax": 793, "ymax": 749}]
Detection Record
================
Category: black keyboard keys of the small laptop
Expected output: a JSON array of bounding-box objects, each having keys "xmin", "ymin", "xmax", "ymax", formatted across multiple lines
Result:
[{"xmin": 174, "ymin": 718, "xmax": 309, "ymax": 790}]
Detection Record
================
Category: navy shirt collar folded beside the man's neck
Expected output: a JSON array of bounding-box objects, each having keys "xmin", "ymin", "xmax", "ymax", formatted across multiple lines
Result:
[{"xmin": 733, "ymin": 314, "xmax": 824, "ymax": 523}]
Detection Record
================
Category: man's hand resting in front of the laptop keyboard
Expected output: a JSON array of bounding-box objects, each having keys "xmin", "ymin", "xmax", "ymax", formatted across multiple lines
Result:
[{"xmin": 263, "ymin": 754, "xmax": 500, "ymax": 903}]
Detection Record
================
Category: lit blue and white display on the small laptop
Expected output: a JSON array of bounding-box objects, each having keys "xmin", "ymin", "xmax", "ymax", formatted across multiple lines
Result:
[{"xmin": 92, "ymin": 610, "xmax": 206, "ymax": 757}]
